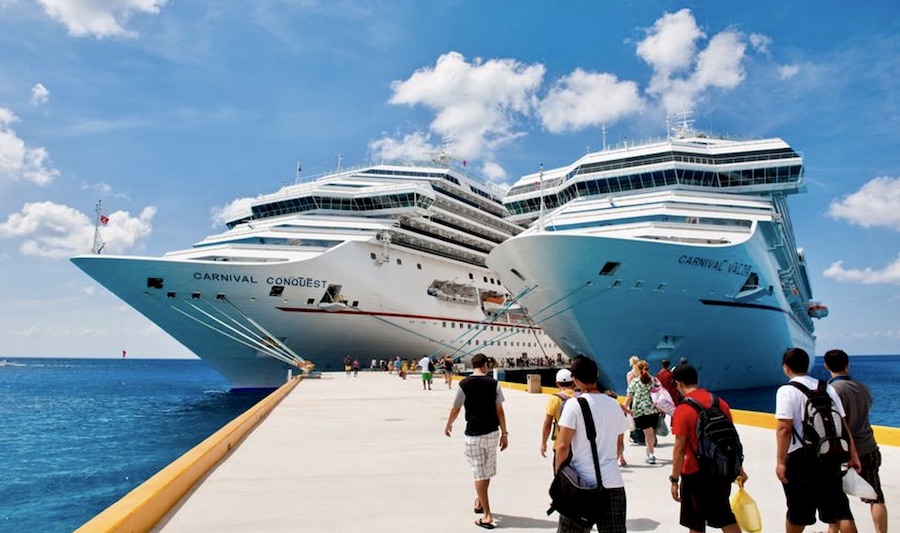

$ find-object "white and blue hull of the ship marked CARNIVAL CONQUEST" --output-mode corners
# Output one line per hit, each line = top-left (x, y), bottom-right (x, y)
(72, 241), (559, 389)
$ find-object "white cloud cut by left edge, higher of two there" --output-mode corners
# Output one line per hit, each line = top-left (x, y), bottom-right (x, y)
(0, 103), (59, 185)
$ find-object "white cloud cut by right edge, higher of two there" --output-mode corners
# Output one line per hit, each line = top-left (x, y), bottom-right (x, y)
(828, 176), (900, 231)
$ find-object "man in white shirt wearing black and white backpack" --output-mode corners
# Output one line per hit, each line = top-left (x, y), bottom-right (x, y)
(775, 348), (860, 533)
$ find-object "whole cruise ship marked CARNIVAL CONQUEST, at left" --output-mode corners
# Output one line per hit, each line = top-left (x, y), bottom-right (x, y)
(72, 160), (562, 390)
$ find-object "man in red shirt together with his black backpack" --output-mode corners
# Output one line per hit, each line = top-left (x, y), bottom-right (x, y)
(669, 364), (747, 533)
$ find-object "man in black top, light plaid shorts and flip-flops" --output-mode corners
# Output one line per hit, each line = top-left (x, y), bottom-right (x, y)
(444, 353), (509, 529)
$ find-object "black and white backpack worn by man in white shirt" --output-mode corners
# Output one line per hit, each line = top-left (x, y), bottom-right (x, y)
(789, 380), (850, 471)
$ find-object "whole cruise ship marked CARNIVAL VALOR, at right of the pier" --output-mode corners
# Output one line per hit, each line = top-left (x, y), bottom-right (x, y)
(487, 121), (828, 392)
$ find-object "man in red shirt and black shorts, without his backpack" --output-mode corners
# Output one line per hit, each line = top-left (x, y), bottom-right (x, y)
(669, 364), (747, 533)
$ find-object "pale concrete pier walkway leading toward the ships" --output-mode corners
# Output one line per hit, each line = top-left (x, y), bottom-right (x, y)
(125, 372), (900, 533)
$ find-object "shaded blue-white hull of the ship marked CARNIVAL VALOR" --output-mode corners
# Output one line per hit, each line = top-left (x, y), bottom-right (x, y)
(488, 232), (815, 393)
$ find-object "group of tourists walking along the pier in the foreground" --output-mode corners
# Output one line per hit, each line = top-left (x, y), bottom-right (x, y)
(444, 348), (887, 533)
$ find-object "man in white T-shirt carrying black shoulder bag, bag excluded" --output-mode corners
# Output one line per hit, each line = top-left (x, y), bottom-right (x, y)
(556, 355), (628, 533)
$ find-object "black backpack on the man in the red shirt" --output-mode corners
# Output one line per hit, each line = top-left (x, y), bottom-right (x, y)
(684, 392), (744, 482)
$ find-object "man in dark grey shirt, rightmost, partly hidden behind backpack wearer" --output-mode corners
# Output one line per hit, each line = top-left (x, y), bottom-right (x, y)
(825, 350), (888, 533)
